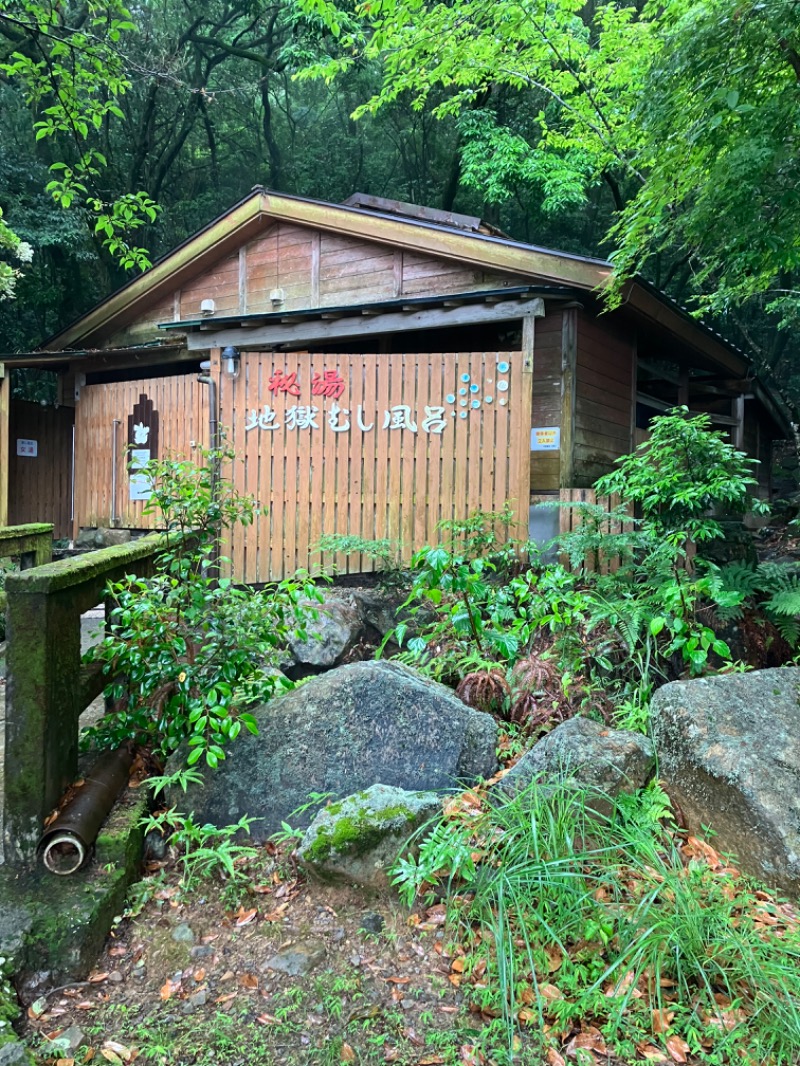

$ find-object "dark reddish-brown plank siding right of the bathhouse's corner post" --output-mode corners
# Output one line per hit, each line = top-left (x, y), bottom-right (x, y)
(573, 313), (635, 486)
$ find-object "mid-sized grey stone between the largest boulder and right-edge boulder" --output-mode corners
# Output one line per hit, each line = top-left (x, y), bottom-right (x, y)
(495, 717), (655, 809)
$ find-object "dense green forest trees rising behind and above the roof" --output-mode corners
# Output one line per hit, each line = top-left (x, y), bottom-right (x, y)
(0, 0), (800, 405)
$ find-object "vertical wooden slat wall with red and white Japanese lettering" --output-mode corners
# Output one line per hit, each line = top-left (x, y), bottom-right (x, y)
(220, 352), (530, 582)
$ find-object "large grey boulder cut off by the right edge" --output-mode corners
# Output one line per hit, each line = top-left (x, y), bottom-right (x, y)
(651, 668), (800, 898)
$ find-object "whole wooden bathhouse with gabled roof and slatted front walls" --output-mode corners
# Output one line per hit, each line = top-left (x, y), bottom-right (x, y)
(0, 188), (789, 582)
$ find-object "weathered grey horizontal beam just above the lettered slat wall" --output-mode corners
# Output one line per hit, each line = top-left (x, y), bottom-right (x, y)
(187, 296), (544, 352)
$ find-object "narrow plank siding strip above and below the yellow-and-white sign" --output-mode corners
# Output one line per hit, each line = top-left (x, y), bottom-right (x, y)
(530, 310), (563, 492)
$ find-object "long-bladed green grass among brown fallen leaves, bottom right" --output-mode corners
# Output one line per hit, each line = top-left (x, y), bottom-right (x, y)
(395, 784), (800, 1066)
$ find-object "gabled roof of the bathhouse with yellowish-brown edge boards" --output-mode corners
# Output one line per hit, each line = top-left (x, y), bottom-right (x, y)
(26, 185), (790, 432)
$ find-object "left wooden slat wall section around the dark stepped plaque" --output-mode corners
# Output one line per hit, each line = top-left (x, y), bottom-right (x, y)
(75, 374), (208, 532)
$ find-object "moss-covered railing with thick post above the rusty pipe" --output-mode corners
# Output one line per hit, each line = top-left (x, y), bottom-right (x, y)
(3, 534), (172, 863)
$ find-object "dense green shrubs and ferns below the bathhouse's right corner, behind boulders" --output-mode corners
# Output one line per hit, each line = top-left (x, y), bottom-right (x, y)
(369, 409), (800, 729)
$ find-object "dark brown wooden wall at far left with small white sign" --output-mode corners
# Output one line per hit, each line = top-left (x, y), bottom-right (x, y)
(9, 400), (74, 539)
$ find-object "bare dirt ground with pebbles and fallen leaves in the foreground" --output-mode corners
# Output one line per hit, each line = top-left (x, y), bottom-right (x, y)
(26, 849), (522, 1066)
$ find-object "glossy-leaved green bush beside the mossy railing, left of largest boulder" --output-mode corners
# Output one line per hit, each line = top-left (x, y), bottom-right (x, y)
(87, 450), (321, 766)
